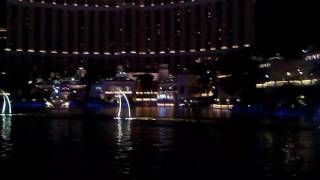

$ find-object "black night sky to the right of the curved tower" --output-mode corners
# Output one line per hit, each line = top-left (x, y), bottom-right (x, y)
(256, 0), (320, 54)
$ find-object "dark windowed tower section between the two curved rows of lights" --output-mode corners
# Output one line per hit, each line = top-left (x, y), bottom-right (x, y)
(8, 3), (244, 54)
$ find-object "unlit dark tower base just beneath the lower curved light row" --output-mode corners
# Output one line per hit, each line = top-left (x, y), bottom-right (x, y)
(1, 53), (228, 76)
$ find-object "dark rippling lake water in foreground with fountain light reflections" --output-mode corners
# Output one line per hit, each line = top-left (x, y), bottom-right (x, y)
(0, 115), (320, 180)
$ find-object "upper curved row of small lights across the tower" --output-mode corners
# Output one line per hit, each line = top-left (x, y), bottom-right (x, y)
(18, 0), (199, 8)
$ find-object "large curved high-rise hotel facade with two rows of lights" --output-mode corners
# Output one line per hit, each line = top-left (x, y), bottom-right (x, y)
(5, 0), (254, 77)
